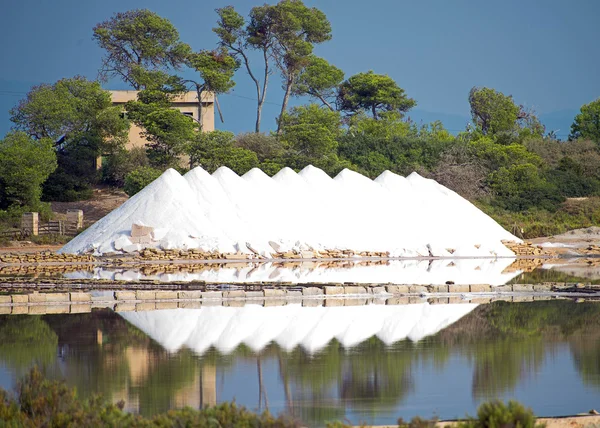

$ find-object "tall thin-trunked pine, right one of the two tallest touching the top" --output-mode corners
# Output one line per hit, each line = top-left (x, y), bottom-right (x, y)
(271, 0), (331, 133)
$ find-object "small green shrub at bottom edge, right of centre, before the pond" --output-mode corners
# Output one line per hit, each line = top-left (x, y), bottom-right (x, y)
(457, 400), (545, 428)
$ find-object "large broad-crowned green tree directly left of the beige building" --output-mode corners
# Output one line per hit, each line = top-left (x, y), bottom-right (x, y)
(11, 77), (129, 201)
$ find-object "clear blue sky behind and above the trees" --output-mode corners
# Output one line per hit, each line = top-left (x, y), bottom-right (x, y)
(0, 0), (600, 138)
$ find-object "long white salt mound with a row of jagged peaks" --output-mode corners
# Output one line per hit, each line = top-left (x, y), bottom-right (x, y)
(60, 166), (519, 258)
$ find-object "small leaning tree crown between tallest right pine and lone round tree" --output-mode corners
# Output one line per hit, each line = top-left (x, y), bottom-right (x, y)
(291, 55), (344, 111)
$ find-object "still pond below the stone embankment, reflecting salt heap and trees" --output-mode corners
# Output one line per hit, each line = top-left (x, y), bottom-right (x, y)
(0, 300), (600, 426)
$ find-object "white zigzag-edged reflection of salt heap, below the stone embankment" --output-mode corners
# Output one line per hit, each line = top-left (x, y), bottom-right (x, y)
(119, 303), (477, 354)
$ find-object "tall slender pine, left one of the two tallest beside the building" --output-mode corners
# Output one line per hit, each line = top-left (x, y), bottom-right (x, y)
(213, 5), (275, 132)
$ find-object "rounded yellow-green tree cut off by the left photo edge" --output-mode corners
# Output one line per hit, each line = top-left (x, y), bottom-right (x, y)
(0, 132), (56, 209)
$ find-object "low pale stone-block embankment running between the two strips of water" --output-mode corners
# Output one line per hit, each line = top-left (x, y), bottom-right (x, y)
(0, 283), (600, 315)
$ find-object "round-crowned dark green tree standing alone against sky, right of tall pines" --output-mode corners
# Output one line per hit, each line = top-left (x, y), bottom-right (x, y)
(337, 71), (417, 119)
